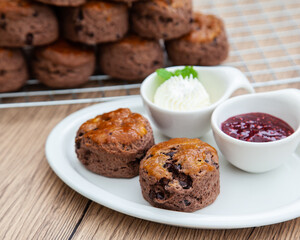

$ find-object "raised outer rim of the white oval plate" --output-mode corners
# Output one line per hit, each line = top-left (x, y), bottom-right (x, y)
(45, 96), (300, 229)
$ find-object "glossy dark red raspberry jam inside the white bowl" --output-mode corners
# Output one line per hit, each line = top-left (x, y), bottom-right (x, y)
(221, 113), (294, 142)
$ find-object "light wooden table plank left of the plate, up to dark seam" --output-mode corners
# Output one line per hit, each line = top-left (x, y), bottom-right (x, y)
(0, 106), (88, 239)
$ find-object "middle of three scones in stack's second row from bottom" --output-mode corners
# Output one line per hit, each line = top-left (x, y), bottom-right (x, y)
(61, 1), (128, 44)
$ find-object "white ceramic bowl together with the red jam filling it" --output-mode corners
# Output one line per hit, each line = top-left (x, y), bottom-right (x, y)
(211, 89), (300, 173)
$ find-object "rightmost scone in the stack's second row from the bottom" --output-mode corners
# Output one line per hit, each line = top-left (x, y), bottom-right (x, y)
(131, 0), (193, 40)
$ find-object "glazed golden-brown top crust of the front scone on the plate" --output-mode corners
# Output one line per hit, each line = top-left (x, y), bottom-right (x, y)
(140, 138), (218, 180)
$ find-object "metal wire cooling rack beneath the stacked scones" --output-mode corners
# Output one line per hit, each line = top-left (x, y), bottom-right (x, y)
(0, 0), (300, 108)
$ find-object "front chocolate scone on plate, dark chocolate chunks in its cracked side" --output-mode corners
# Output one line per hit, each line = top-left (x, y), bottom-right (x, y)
(140, 138), (220, 212)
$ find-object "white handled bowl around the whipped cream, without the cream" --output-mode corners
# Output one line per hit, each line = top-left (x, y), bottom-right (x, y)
(141, 66), (254, 138)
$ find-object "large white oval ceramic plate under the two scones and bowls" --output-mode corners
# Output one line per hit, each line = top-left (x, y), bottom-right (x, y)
(46, 97), (300, 229)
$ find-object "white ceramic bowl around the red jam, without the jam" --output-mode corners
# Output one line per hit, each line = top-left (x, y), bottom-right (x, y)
(211, 89), (300, 173)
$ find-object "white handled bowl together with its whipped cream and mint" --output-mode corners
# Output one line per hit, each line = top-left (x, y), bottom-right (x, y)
(141, 66), (254, 138)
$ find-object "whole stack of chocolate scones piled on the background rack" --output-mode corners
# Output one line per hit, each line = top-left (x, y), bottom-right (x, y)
(0, 0), (229, 92)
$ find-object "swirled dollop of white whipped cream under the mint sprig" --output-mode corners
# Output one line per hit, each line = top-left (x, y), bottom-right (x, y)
(154, 75), (211, 111)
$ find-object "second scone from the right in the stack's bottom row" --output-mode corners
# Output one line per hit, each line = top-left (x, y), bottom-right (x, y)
(99, 34), (163, 80)
